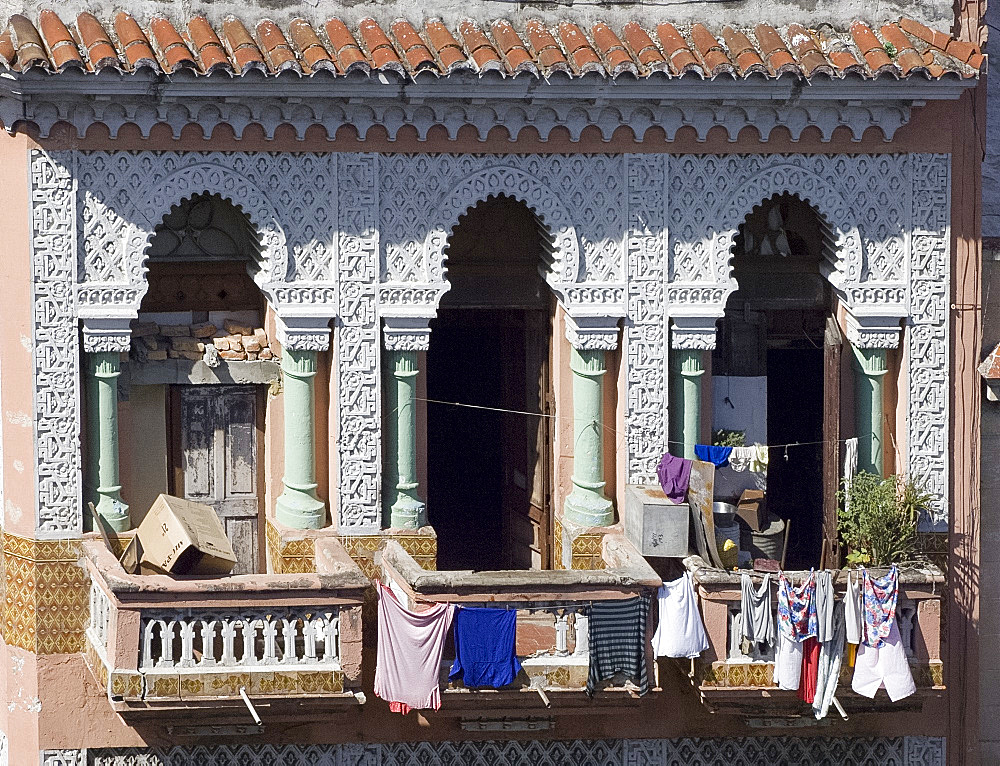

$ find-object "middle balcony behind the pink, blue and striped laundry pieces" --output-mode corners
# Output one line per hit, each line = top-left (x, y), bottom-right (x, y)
(377, 535), (661, 715)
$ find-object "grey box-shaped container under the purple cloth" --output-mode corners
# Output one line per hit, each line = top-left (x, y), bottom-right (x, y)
(623, 484), (691, 557)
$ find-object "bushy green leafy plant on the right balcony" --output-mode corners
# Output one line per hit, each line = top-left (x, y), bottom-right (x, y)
(837, 472), (933, 566)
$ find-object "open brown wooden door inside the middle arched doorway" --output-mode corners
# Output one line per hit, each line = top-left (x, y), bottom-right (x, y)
(502, 310), (553, 569)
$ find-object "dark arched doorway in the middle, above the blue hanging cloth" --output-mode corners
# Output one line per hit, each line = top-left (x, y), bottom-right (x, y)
(427, 196), (554, 570)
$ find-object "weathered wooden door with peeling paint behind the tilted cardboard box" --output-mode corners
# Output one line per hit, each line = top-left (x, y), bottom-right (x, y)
(170, 385), (263, 574)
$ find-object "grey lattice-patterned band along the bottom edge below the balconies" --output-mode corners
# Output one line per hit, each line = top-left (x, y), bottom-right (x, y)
(86, 737), (945, 766)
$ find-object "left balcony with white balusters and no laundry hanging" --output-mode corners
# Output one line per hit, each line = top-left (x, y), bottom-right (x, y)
(84, 540), (370, 722)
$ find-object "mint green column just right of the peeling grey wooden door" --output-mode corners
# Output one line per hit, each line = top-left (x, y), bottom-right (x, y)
(274, 348), (326, 529)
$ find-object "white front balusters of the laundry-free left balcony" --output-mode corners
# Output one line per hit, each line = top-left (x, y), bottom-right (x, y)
(139, 608), (339, 670)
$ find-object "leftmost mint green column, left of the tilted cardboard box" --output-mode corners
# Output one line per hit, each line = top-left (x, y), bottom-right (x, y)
(87, 351), (131, 532)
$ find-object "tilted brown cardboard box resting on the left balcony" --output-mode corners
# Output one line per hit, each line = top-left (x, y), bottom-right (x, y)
(136, 495), (236, 575)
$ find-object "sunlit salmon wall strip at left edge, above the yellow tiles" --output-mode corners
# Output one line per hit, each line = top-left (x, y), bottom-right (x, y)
(0, 132), (35, 537)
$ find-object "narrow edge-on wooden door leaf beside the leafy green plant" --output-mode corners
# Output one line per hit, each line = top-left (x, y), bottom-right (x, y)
(820, 317), (844, 569)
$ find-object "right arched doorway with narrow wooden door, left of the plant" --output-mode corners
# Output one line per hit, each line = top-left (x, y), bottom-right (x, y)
(712, 194), (842, 569)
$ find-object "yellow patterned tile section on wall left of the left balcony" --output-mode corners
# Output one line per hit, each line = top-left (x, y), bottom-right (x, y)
(0, 532), (90, 654)
